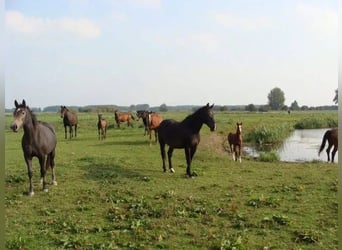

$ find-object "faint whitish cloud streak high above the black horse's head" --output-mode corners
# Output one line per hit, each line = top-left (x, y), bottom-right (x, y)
(213, 13), (271, 31)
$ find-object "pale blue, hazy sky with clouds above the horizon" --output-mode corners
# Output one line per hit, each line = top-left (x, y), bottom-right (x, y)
(5, 0), (338, 108)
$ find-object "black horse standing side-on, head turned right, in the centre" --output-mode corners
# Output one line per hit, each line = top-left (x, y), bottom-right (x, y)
(158, 103), (216, 177)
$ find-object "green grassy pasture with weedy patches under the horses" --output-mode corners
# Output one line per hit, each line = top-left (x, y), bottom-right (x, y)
(5, 112), (338, 250)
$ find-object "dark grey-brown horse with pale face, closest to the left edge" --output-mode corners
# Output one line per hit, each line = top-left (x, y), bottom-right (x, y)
(11, 100), (57, 196)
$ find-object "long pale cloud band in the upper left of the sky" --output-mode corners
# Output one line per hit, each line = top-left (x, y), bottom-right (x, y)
(5, 11), (101, 38)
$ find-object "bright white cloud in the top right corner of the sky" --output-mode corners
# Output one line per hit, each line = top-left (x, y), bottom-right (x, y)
(296, 3), (338, 38)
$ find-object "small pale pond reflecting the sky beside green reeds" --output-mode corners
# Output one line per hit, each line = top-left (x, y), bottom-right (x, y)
(244, 129), (338, 162)
